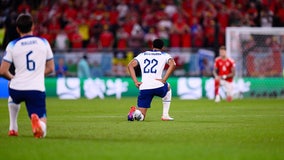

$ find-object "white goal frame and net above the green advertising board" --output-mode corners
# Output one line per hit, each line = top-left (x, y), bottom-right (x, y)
(226, 27), (284, 77)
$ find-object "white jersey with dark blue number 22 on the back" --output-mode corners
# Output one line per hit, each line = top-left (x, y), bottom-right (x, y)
(135, 51), (172, 90)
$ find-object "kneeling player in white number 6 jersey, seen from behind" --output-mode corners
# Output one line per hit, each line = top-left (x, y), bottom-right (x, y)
(0, 14), (54, 138)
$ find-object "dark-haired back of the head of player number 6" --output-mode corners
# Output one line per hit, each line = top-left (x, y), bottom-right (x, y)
(16, 13), (33, 33)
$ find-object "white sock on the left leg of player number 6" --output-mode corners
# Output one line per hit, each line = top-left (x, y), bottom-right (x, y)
(8, 97), (21, 131)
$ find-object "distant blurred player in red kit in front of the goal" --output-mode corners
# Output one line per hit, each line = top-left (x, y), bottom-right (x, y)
(213, 46), (235, 102)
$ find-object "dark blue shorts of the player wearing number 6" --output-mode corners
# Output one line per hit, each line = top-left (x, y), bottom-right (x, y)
(9, 88), (46, 118)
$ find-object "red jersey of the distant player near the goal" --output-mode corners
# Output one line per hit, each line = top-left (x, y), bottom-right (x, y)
(214, 57), (235, 82)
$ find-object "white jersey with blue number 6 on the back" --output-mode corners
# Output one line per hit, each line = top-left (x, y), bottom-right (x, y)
(3, 36), (53, 91)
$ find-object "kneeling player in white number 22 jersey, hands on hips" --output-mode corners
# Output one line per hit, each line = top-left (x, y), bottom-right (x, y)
(128, 39), (176, 121)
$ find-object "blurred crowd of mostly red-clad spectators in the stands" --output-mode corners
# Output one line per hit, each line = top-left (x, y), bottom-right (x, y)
(0, 0), (284, 52)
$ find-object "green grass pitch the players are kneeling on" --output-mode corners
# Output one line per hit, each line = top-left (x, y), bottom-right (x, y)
(0, 98), (284, 160)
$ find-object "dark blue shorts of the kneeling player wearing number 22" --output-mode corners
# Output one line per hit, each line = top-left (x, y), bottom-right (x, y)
(137, 83), (169, 108)
